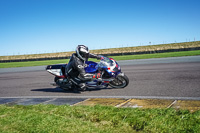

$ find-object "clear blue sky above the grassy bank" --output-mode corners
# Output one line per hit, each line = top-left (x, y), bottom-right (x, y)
(0, 0), (200, 56)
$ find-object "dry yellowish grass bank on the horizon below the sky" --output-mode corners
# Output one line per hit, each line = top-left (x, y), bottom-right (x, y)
(0, 41), (200, 60)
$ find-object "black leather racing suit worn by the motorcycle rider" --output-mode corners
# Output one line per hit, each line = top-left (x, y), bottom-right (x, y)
(65, 53), (100, 86)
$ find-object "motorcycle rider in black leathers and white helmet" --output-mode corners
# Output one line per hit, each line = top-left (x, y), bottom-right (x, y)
(65, 45), (101, 91)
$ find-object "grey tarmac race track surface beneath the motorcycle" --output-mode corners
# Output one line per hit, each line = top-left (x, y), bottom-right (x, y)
(0, 56), (200, 105)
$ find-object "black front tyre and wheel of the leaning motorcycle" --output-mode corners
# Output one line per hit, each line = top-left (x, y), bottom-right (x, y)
(109, 74), (129, 88)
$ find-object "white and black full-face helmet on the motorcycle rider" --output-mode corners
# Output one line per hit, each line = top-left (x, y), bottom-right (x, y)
(76, 45), (89, 61)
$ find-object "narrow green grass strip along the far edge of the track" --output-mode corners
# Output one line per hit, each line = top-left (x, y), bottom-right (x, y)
(0, 50), (200, 68)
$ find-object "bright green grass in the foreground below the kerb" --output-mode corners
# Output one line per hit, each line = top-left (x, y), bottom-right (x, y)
(0, 104), (200, 133)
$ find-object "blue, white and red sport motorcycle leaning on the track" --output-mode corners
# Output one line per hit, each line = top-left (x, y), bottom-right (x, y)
(46, 56), (129, 90)
